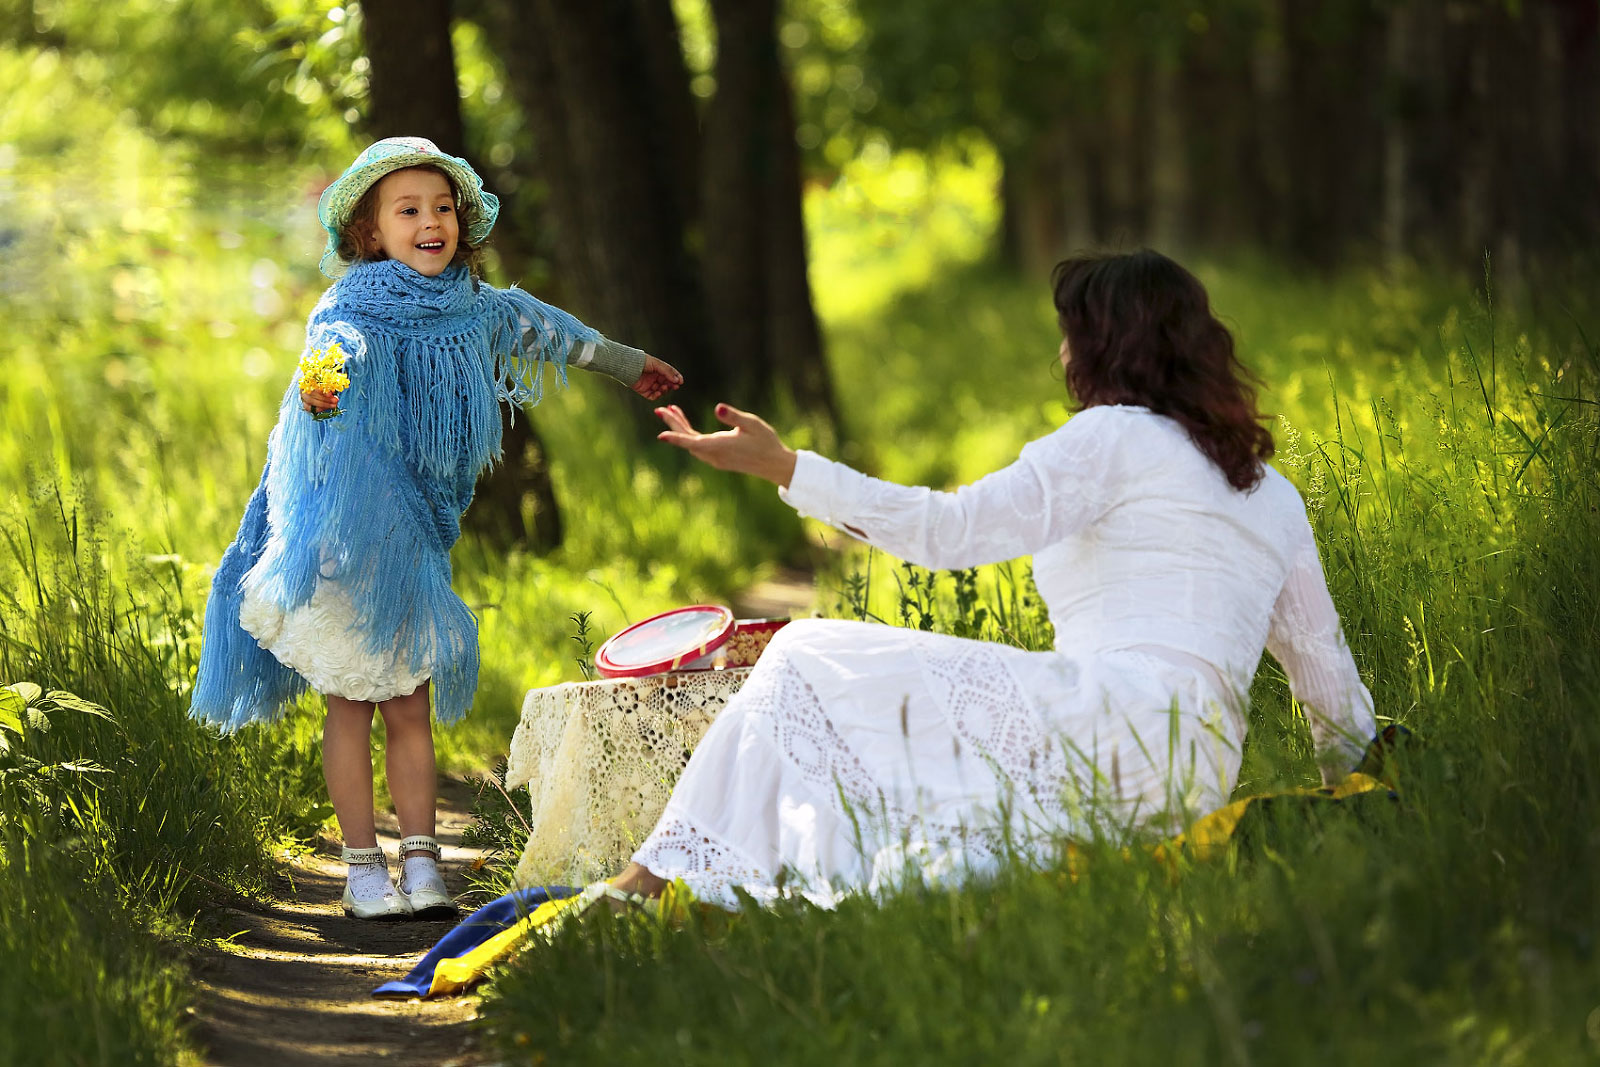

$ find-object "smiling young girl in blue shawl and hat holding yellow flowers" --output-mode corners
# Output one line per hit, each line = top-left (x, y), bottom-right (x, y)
(190, 138), (682, 918)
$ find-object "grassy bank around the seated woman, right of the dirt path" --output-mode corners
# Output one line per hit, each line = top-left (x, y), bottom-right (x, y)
(473, 267), (1600, 1064)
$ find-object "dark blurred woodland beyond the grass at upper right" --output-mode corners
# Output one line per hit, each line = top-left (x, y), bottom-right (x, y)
(808, 0), (1600, 277)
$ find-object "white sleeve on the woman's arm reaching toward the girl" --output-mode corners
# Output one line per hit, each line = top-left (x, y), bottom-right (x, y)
(781, 408), (1115, 569)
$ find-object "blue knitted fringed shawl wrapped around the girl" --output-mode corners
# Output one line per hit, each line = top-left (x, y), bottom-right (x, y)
(189, 259), (600, 729)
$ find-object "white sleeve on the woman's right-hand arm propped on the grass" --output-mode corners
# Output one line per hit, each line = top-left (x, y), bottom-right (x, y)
(1267, 518), (1376, 776)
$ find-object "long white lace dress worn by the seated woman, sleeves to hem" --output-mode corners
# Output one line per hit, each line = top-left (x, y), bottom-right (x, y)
(634, 406), (1374, 907)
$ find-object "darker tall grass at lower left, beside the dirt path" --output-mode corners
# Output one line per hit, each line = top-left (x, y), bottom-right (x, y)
(0, 498), (323, 1065)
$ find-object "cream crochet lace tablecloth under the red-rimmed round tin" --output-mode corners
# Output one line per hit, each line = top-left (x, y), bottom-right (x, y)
(506, 669), (750, 885)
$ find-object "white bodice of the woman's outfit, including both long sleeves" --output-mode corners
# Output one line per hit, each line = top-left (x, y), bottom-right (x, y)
(782, 406), (1374, 766)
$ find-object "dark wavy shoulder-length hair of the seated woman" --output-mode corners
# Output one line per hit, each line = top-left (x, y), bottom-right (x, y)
(1051, 250), (1272, 490)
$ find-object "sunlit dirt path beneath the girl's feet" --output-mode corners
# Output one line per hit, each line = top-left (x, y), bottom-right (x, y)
(186, 779), (490, 1067)
